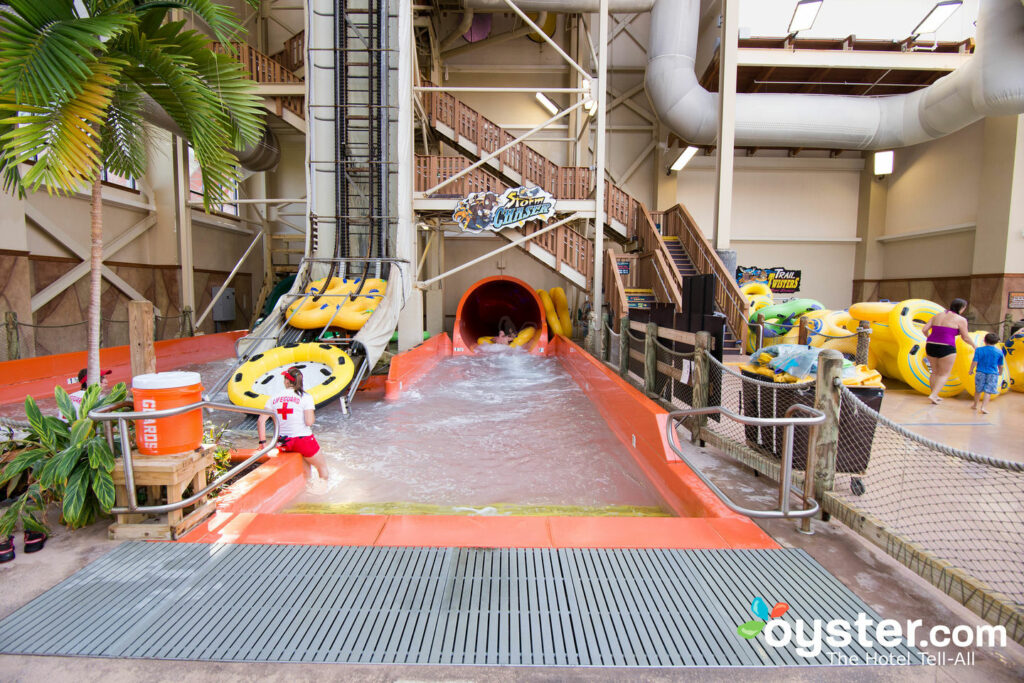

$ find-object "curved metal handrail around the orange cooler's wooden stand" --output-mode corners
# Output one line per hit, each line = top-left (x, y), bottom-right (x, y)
(89, 400), (281, 514)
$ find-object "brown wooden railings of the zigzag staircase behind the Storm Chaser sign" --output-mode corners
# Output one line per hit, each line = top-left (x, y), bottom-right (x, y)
(416, 83), (746, 341)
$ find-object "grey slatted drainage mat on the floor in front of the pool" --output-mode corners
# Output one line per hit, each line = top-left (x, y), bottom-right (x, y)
(0, 543), (920, 667)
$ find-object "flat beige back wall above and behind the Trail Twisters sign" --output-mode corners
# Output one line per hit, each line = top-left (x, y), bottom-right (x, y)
(660, 157), (862, 308)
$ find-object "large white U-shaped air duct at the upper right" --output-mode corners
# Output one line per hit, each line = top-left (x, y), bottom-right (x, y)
(647, 0), (1024, 150)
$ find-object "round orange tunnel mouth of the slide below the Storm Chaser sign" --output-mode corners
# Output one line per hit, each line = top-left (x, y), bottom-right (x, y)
(452, 275), (548, 355)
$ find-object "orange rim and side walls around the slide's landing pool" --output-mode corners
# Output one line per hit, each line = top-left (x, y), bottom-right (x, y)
(180, 334), (779, 549)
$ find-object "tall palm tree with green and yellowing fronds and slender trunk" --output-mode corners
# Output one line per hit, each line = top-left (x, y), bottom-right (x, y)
(0, 0), (263, 384)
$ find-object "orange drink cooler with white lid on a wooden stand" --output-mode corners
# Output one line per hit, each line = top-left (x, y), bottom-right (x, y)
(131, 372), (203, 456)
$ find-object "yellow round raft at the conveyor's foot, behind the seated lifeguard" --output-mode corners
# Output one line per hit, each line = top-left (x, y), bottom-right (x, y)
(227, 343), (355, 408)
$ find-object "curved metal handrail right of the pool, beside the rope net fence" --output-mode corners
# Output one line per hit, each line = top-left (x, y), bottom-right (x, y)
(665, 403), (825, 519)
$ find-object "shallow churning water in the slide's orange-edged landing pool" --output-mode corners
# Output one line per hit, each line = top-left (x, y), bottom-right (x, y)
(284, 347), (666, 508)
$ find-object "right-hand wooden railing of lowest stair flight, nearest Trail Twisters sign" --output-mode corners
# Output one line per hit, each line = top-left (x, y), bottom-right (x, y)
(657, 204), (750, 348)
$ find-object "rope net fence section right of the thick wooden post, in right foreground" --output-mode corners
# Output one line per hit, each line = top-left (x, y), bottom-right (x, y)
(833, 387), (1024, 609)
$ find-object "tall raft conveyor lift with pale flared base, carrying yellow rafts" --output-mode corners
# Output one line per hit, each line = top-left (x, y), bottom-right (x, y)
(210, 0), (413, 405)
